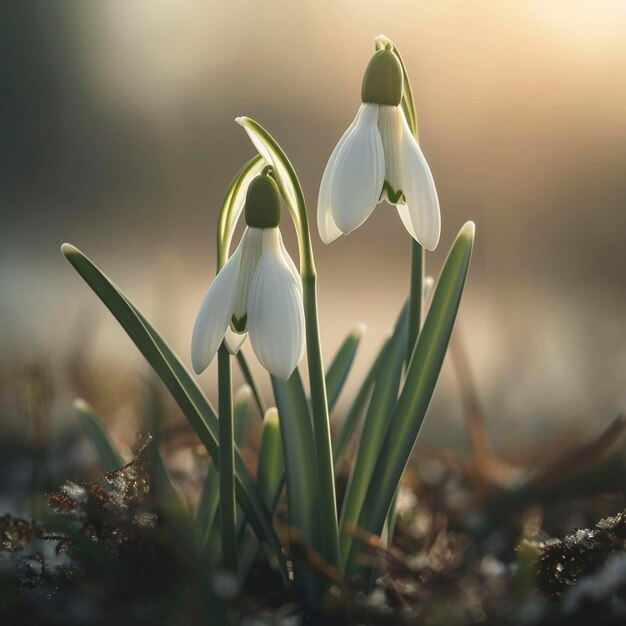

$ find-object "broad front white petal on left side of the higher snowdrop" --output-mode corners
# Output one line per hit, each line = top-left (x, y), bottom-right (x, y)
(330, 104), (385, 235)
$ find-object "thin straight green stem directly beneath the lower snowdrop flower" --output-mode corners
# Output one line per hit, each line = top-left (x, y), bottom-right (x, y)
(217, 344), (237, 574)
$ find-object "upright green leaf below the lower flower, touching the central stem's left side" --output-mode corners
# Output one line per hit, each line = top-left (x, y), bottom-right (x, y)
(272, 368), (321, 592)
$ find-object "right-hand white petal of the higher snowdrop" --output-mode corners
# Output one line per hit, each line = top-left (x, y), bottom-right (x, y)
(401, 108), (441, 250)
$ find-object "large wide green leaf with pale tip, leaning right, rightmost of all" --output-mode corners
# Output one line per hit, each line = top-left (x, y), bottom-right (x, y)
(347, 222), (475, 573)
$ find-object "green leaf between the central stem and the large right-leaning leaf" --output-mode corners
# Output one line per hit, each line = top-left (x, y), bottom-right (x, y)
(340, 304), (408, 563)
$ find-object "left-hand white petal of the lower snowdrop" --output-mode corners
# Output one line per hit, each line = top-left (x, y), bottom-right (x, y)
(191, 242), (243, 374)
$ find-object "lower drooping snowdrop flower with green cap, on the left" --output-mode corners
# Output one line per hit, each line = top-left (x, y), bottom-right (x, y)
(191, 175), (304, 380)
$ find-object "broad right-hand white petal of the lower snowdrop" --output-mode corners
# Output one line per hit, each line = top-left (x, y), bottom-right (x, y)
(248, 228), (304, 380)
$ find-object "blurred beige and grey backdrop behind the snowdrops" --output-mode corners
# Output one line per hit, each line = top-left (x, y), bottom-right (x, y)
(0, 0), (626, 468)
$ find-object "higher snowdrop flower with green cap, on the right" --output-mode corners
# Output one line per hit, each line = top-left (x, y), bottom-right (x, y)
(317, 44), (441, 250)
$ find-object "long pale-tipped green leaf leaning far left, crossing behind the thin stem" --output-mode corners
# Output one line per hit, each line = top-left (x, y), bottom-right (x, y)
(62, 244), (289, 584)
